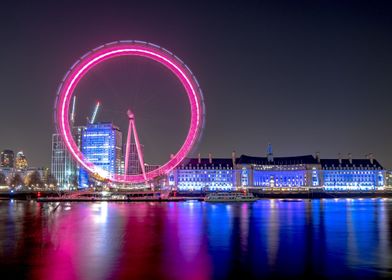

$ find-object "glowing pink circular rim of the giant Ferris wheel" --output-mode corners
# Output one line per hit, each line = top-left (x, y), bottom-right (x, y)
(54, 41), (205, 184)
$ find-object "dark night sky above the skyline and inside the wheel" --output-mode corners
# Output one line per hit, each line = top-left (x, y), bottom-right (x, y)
(0, 0), (392, 168)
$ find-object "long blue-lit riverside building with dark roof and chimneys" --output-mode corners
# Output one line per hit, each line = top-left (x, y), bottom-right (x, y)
(174, 152), (386, 191)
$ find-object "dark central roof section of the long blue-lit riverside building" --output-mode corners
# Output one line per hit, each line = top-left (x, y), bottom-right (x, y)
(236, 155), (318, 165)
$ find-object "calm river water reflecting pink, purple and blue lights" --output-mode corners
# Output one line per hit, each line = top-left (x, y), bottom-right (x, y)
(0, 198), (392, 280)
